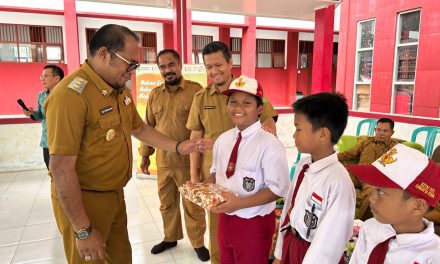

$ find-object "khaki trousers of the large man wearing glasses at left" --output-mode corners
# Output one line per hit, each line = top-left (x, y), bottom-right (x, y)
(51, 182), (132, 264)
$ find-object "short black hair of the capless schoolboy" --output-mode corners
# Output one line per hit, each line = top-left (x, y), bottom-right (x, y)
(292, 93), (348, 144)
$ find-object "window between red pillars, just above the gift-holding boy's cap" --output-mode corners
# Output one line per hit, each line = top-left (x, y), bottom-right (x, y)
(257, 39), (285, 68)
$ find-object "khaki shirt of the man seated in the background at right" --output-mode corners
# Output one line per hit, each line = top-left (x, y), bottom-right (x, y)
(338, 136), (401, 164)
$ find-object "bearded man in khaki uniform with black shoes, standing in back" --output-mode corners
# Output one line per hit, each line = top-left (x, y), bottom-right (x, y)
(140, 49), (209, 261)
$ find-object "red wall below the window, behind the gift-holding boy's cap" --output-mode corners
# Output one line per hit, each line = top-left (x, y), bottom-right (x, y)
(232, 67), (292, 106)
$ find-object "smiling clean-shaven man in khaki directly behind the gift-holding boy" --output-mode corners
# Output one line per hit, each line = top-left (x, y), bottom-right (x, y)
(186, 41), (277, 263)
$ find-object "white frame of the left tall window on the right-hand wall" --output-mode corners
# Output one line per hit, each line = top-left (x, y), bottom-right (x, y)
(352, 18), (376, 112)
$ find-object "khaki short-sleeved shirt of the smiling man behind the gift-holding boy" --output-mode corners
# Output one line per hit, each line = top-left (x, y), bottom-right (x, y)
(186, 84), (278, 173)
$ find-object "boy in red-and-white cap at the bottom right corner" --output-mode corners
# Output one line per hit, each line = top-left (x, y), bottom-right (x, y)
(348, 144), (440, 264)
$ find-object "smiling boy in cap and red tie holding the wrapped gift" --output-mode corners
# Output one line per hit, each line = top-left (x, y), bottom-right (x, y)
(207, 76), (289, 264)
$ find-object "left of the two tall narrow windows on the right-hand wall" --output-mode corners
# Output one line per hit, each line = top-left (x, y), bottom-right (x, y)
(353, 20), (375, 111)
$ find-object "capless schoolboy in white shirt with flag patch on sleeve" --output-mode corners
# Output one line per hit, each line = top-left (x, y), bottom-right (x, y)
(273, 93), (355, 264)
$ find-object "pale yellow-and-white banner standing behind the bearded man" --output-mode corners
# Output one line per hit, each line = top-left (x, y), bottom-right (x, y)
(136, 64), (207, 174)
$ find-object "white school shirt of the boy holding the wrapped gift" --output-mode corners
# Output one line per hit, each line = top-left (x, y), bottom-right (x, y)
(210, 121), (289, 219)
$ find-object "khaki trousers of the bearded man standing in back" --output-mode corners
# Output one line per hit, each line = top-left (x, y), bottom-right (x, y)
(157, 167), (206, 248)
